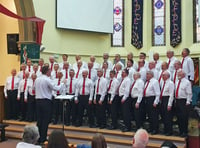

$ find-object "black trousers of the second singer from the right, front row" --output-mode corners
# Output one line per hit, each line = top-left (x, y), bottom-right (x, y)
(160, 96), (173, 133)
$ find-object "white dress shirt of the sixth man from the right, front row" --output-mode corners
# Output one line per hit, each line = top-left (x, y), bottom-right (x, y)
(107, 78), (119, 101)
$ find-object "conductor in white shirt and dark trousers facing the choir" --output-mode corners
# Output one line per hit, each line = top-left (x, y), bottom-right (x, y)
(35, 66), (62, 143)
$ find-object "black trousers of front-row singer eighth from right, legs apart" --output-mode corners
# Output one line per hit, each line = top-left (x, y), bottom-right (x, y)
(78, 95), (94, 125)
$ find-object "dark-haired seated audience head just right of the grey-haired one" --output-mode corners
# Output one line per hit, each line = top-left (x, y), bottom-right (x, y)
(48, 130), (69, 148)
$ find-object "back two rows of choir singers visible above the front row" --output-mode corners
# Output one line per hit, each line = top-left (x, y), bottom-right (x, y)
(18, 48), (194, 82)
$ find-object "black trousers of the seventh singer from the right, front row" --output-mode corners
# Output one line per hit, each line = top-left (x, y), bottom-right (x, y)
(96, 95), (106, 127)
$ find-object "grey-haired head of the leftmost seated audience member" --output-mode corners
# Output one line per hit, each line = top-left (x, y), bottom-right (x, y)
(22, 125), (40, 144)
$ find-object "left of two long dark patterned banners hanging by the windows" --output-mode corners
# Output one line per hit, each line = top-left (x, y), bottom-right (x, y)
(131, 0), (143, 49)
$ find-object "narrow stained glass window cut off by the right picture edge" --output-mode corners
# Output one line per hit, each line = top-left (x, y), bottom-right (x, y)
(193, 0), (200, 42)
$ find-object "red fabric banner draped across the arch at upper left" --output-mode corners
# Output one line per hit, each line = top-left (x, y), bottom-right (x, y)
(0, 4), (45, 45)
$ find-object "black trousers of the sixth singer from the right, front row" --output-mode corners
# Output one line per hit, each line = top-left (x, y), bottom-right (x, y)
(111, 95), (121, 128)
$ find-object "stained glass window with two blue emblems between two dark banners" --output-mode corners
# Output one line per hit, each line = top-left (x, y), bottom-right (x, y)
(152, 0), (165, 46)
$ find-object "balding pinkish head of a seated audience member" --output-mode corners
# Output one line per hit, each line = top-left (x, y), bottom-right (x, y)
(133, 129), (149, 148)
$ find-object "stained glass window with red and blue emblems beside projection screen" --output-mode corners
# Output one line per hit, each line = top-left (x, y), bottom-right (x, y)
(111, 0), (124, 47)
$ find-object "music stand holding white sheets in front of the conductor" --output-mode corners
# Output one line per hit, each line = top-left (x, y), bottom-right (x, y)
(55, 95), (75, 131)
